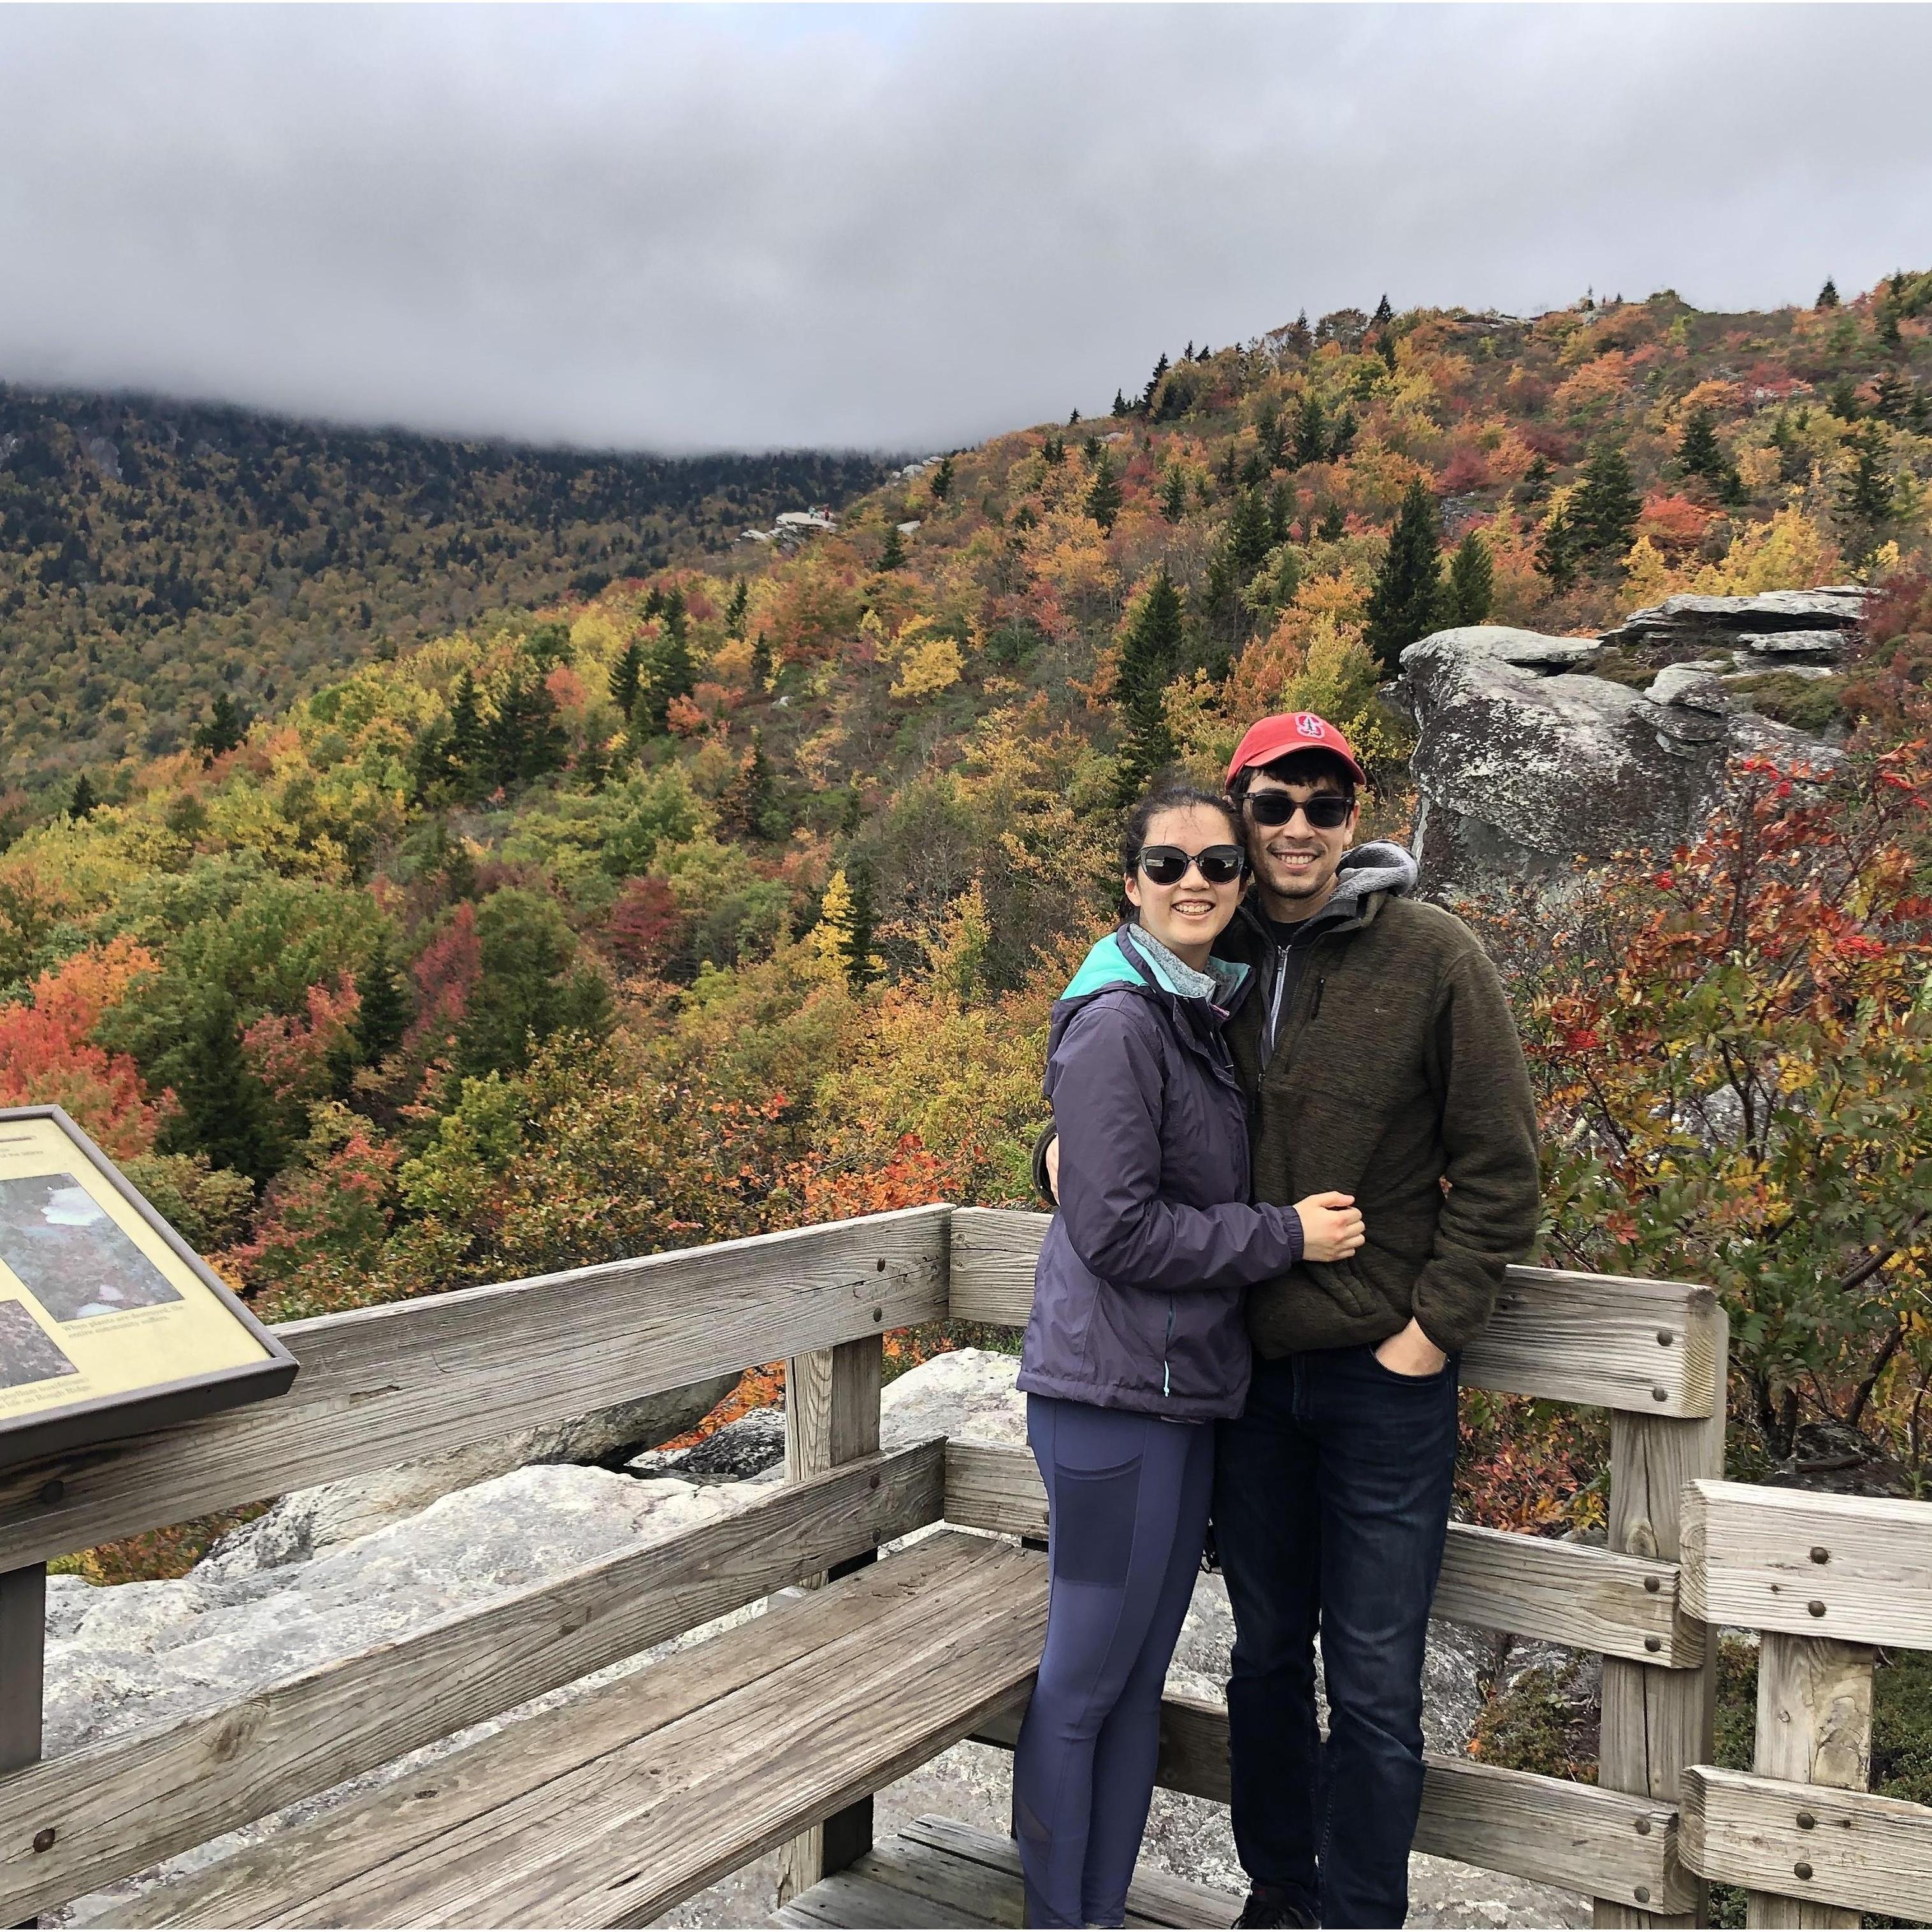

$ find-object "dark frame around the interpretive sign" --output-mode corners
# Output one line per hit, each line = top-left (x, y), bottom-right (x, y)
(0, 1105), (301, 1470)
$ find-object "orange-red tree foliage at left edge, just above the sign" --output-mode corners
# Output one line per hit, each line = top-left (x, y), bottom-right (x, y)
(0, 937), (172, 1161)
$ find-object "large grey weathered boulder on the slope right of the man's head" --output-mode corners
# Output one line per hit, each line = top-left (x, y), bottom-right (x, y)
(1399, 622), (1839, 893)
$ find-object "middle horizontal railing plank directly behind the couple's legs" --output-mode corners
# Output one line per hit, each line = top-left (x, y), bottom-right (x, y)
(947, 1439), (1704, 1669)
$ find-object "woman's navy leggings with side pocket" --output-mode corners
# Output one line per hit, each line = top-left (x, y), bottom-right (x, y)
(1013, 1395), (1213, 1926)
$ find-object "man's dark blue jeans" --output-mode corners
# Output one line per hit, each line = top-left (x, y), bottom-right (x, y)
(1213, 1348), (1457, 1926)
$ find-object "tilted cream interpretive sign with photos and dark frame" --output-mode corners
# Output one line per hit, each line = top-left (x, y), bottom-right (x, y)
(0, 1107), (296, 1464)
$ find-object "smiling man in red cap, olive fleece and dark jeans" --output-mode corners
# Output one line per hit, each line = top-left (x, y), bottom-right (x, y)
(1053, 711), (1540, 1926)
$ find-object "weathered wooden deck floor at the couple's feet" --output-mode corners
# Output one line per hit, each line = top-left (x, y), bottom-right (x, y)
(779, 1818), (1241, 1932)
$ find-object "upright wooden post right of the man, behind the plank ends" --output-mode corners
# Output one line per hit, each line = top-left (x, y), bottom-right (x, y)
(1590, 1310), (1729, 1926)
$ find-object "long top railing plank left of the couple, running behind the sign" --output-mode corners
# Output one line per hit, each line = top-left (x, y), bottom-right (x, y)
(0, 1208), (953, 1569)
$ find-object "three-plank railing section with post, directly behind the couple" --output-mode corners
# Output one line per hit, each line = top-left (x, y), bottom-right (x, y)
(947, 1208), (1727, 1926)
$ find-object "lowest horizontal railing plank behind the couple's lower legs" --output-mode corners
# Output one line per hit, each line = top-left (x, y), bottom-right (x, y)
(974, 1696), (1694, 1911)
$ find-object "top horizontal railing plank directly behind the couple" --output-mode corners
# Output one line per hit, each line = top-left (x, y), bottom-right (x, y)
(951, 1208), (1724, 1416)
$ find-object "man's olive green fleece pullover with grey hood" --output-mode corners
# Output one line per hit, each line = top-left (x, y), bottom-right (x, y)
(1215, 846), (1542, 1356)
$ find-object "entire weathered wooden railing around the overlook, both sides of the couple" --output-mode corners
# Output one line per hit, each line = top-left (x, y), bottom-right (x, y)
(0, 1206), (1932, 1924)
